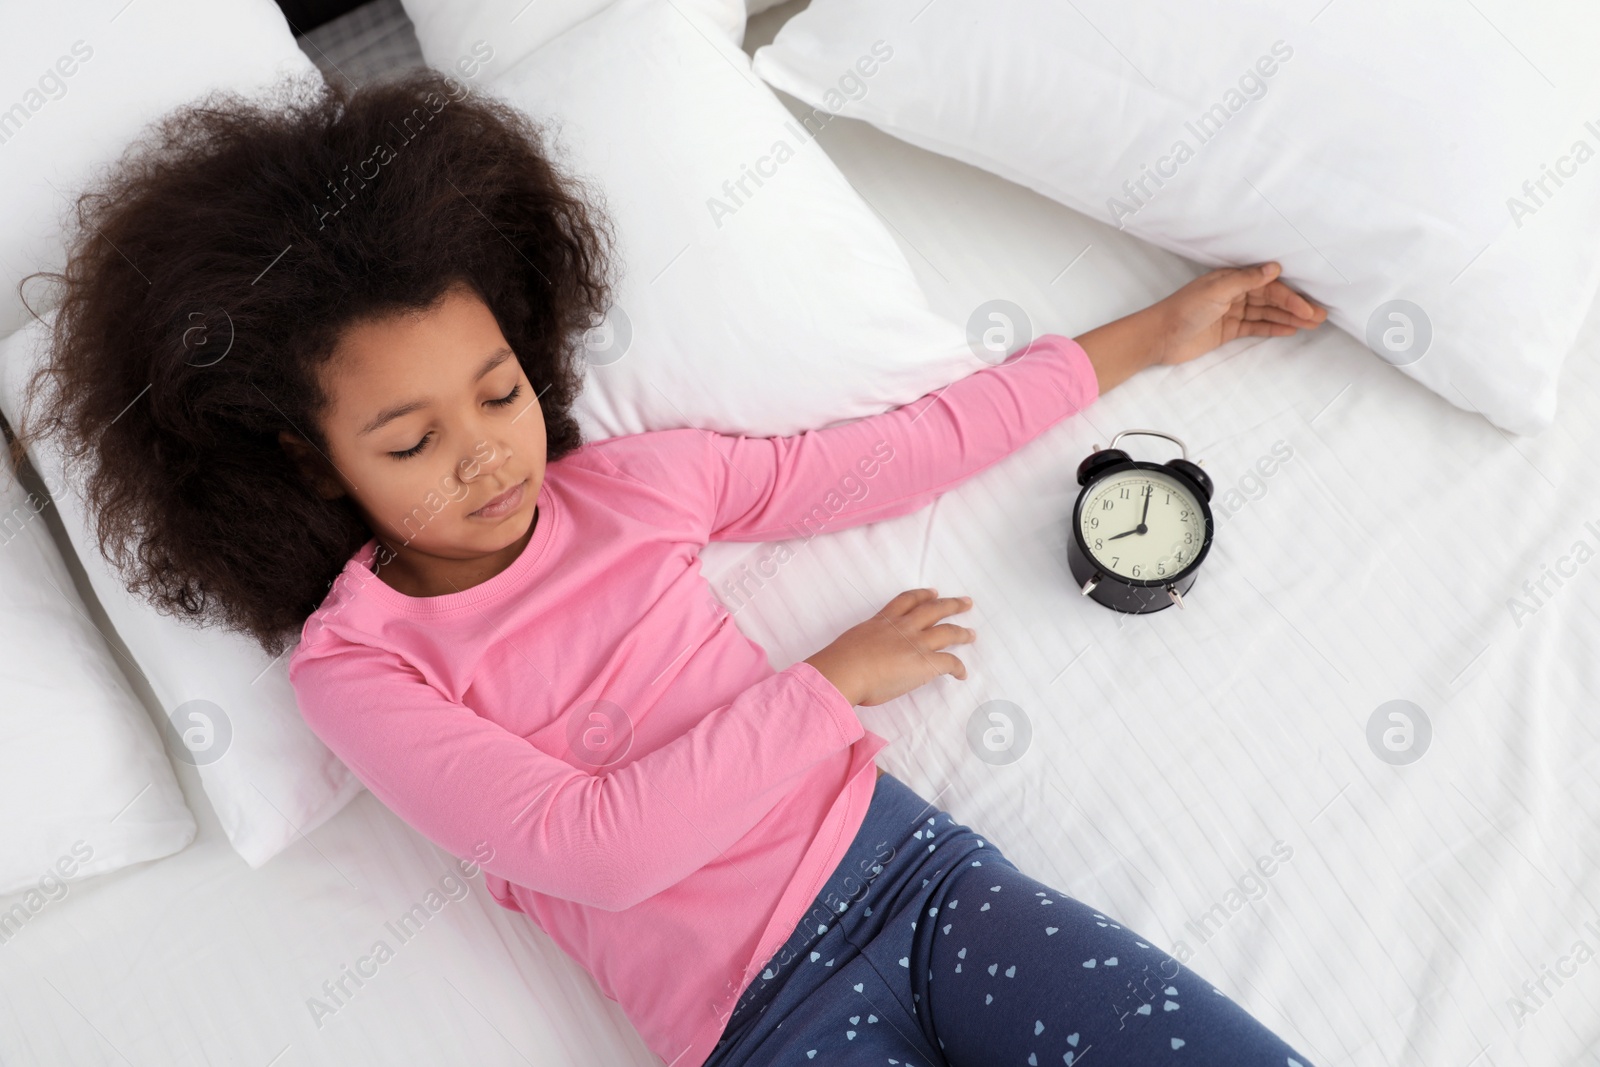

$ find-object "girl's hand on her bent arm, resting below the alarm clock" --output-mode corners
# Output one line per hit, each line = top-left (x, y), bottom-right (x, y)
(806, 589), (978, 707)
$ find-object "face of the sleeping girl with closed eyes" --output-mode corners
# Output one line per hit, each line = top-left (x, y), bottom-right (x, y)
(280, 286), (546, 597)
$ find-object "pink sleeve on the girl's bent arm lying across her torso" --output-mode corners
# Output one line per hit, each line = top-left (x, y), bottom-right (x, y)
(291, 638), (866, 912)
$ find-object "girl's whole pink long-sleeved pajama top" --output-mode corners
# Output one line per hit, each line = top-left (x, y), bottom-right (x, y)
(290, 334), (1098, 1067)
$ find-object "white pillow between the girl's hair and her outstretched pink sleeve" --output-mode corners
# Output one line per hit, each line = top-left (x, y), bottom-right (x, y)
(473, 0), (986, 437)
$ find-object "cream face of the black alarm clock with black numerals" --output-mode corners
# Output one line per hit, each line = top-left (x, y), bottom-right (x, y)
(1078, 469), (1205, 582)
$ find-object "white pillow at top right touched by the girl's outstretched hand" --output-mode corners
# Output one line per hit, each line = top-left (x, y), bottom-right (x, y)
(755, 0), (1600, 432)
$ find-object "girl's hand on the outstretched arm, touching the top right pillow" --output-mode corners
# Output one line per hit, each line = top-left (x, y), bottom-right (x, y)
(1150, 262), (1328, 363)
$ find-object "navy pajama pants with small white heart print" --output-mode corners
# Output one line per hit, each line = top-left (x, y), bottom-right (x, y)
(706, 774), (1314, 1067)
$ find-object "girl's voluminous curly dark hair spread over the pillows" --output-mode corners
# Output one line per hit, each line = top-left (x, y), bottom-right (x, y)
(14, 70), (613, 656)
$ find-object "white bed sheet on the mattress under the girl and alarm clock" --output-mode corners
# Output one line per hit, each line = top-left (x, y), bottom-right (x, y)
(0, 10), (1600, 1067)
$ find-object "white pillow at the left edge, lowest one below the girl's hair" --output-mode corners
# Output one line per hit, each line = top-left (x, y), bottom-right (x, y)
(0, 438), (195, 895)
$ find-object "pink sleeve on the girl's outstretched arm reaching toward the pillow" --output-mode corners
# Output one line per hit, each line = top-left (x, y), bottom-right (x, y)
(654, 334), (1099, 541)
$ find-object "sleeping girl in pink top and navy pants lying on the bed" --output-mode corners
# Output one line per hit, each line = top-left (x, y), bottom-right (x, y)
(21, 72), (1325, 1067)
